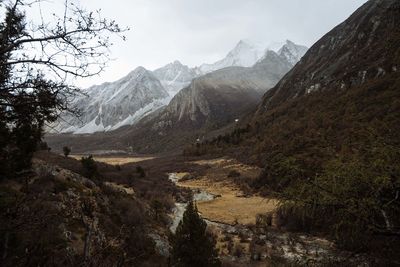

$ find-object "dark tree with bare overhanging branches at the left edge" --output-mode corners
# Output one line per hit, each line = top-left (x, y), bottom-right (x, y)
(0, 0), (125, 177)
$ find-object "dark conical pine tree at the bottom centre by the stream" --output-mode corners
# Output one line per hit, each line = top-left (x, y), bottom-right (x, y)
(171, 202), (221, 267)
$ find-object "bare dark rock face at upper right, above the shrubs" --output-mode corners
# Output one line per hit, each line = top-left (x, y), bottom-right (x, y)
(259, 0), (400, 112)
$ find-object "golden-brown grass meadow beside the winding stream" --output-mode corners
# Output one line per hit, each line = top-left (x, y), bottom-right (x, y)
(178, 159), (277, 227)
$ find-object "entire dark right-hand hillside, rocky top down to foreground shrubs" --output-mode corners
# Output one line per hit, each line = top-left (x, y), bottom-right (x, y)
(191, 0), (400, 266)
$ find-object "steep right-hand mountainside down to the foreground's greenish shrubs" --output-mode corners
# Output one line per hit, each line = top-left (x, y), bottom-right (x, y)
(206, 0), (400, 175)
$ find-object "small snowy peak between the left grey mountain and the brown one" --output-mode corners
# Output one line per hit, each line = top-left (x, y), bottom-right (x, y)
(153, 61), (197, 97)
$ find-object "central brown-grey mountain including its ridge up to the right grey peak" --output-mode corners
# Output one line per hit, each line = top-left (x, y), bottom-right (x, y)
(158, 51), (291, 130)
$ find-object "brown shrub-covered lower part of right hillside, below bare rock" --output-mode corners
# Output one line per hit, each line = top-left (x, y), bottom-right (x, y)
(190, 74), (400, 257)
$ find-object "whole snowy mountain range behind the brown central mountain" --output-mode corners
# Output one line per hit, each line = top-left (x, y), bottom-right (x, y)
(50, 41), (307, 134)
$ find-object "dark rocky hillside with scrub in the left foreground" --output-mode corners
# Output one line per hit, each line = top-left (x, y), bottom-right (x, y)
(0, 151), (182, 267)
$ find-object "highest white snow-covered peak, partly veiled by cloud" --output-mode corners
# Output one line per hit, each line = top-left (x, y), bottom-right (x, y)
(198, 40), (265, 74)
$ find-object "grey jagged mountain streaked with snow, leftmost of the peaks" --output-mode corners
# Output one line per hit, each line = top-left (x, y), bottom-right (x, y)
(54, 67), (169, 134)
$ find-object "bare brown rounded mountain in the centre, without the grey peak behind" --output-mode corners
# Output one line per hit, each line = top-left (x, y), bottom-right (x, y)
(159, 67), (267, 129)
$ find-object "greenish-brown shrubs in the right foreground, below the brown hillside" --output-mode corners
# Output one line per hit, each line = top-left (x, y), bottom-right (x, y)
(279, 138), (400, 249)
